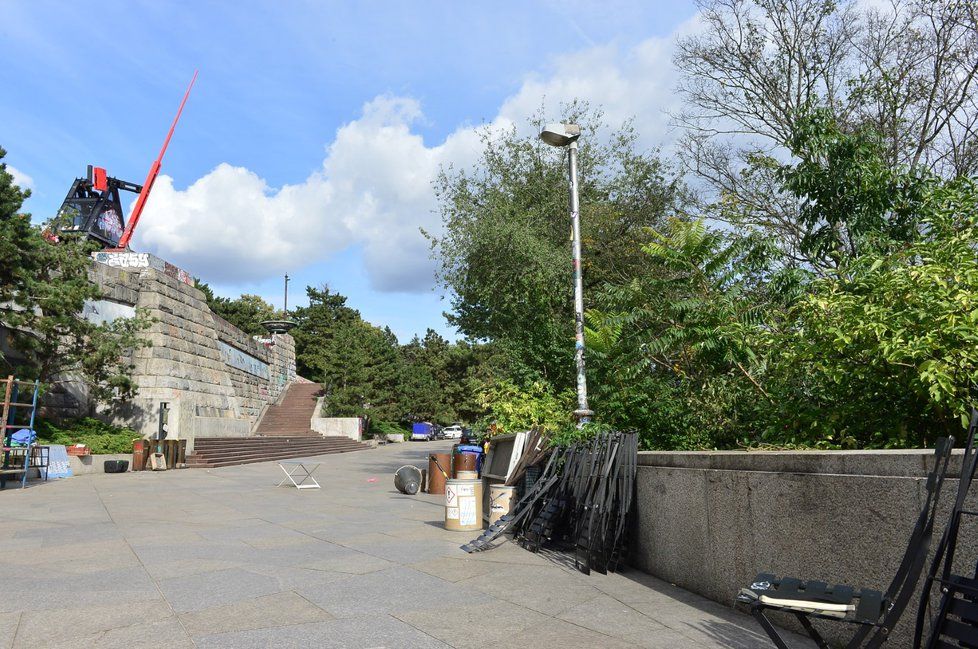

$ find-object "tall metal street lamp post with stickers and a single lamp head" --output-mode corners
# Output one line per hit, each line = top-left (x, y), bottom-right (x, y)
(540, 124), (594, 427)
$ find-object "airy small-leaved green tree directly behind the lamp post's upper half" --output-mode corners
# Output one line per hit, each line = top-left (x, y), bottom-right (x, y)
(432, 104), (681, 389)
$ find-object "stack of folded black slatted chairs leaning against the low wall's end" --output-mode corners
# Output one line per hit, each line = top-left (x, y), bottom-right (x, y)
(462, 432), (638, 574)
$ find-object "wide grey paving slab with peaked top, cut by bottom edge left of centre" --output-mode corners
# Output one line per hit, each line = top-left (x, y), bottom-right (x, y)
(195, 615), (450, 649)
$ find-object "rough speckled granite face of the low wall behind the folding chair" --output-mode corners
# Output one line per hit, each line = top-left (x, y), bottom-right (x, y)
(629, 450), (978, 647)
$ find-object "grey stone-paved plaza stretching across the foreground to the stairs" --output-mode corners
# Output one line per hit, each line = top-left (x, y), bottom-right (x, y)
(0, 442), (801, 649)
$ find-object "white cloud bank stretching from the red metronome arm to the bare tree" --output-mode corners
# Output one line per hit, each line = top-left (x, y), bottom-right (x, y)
(137, 23), (688, 291)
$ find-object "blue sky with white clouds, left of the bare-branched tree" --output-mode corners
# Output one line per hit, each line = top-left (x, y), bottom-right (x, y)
(0, 0), (695, 341)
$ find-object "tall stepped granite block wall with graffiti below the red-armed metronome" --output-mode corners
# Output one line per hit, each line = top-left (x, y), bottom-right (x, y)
(44, 253), (295, 452)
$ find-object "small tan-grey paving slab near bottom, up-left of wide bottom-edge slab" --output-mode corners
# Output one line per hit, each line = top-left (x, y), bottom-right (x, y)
(180, 591), (333, 636)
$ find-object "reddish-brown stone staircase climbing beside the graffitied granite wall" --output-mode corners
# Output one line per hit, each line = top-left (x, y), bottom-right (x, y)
(187, 383), (370, 468)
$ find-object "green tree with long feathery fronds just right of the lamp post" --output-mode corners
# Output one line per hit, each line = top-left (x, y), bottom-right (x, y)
(587, 219), (784, 449)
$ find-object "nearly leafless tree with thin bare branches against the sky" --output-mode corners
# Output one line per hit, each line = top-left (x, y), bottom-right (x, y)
(675, 0), (978, 272)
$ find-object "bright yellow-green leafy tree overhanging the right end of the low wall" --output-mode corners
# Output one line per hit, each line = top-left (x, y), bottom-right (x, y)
(758, 179), (978, 447)
